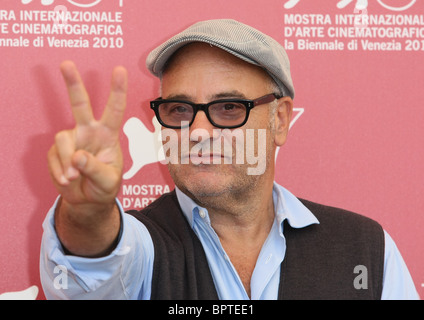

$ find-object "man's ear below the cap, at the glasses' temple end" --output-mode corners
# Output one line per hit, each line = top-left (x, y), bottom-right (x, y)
(274, 97), (293, 147)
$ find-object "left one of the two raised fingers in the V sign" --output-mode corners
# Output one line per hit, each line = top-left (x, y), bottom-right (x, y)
(60, 61), (94, 124)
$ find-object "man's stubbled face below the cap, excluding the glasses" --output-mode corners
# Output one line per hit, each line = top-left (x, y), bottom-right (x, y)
(162, 43), (290, 204)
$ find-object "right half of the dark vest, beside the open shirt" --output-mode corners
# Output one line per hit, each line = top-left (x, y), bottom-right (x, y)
(283, 199), (384, 299)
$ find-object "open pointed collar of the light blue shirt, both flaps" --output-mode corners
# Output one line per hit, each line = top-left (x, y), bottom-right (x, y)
(175, 182), (319, 230)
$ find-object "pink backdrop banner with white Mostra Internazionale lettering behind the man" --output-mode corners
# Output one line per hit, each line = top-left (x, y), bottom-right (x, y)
(0, 0), (424, 299)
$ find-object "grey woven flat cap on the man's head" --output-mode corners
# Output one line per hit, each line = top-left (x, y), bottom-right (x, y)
(146, 20), (294, 98)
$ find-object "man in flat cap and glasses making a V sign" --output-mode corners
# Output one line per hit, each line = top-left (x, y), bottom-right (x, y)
(41, 20), (417, 299)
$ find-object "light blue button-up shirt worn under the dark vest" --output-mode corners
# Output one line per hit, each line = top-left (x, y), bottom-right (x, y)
(40, 183), (419, 300)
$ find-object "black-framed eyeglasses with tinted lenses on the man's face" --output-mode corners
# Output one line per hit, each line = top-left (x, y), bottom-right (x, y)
(150, 93), (281, 129)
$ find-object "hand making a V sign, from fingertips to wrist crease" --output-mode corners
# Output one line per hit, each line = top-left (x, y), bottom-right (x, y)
(48, 61), (127, 204)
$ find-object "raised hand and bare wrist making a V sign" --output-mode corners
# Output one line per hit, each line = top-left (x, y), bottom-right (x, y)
(48, 61), (127, 255)
